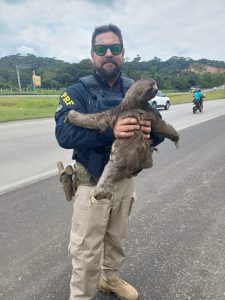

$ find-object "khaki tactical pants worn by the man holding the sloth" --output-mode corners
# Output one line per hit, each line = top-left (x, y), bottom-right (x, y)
(69, 178), (134, 300)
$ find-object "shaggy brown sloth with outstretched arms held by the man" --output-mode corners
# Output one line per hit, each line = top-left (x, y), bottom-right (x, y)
(65, 78), (179, 202)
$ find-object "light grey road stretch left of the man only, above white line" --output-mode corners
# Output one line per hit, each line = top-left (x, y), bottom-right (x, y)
(0, 119), (72, 193)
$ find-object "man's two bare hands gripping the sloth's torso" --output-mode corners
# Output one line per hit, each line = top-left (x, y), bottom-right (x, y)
(113, 118), (151, 139)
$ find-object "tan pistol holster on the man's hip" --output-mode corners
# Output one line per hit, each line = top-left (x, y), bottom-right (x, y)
(57, 161), (79, 201)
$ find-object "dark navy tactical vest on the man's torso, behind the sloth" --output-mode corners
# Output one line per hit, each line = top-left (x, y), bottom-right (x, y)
(74, 75), (134, 177)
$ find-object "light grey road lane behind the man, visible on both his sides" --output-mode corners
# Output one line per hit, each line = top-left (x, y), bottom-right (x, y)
(0, 99), (225, 193)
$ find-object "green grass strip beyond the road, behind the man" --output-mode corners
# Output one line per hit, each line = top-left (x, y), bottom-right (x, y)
(0, 89), (225, 122)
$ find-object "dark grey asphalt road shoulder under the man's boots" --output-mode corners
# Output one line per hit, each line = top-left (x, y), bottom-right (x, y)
(0, 102), (225, 300)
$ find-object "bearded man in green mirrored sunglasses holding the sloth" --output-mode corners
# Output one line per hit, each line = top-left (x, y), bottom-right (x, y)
(55, 24), (162, 300)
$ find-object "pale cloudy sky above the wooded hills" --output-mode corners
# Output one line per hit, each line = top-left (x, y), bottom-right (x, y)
(0, 0), (225, 63)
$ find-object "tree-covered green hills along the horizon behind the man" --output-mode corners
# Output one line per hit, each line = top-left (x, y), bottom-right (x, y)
(0, 54), (225, 91)
